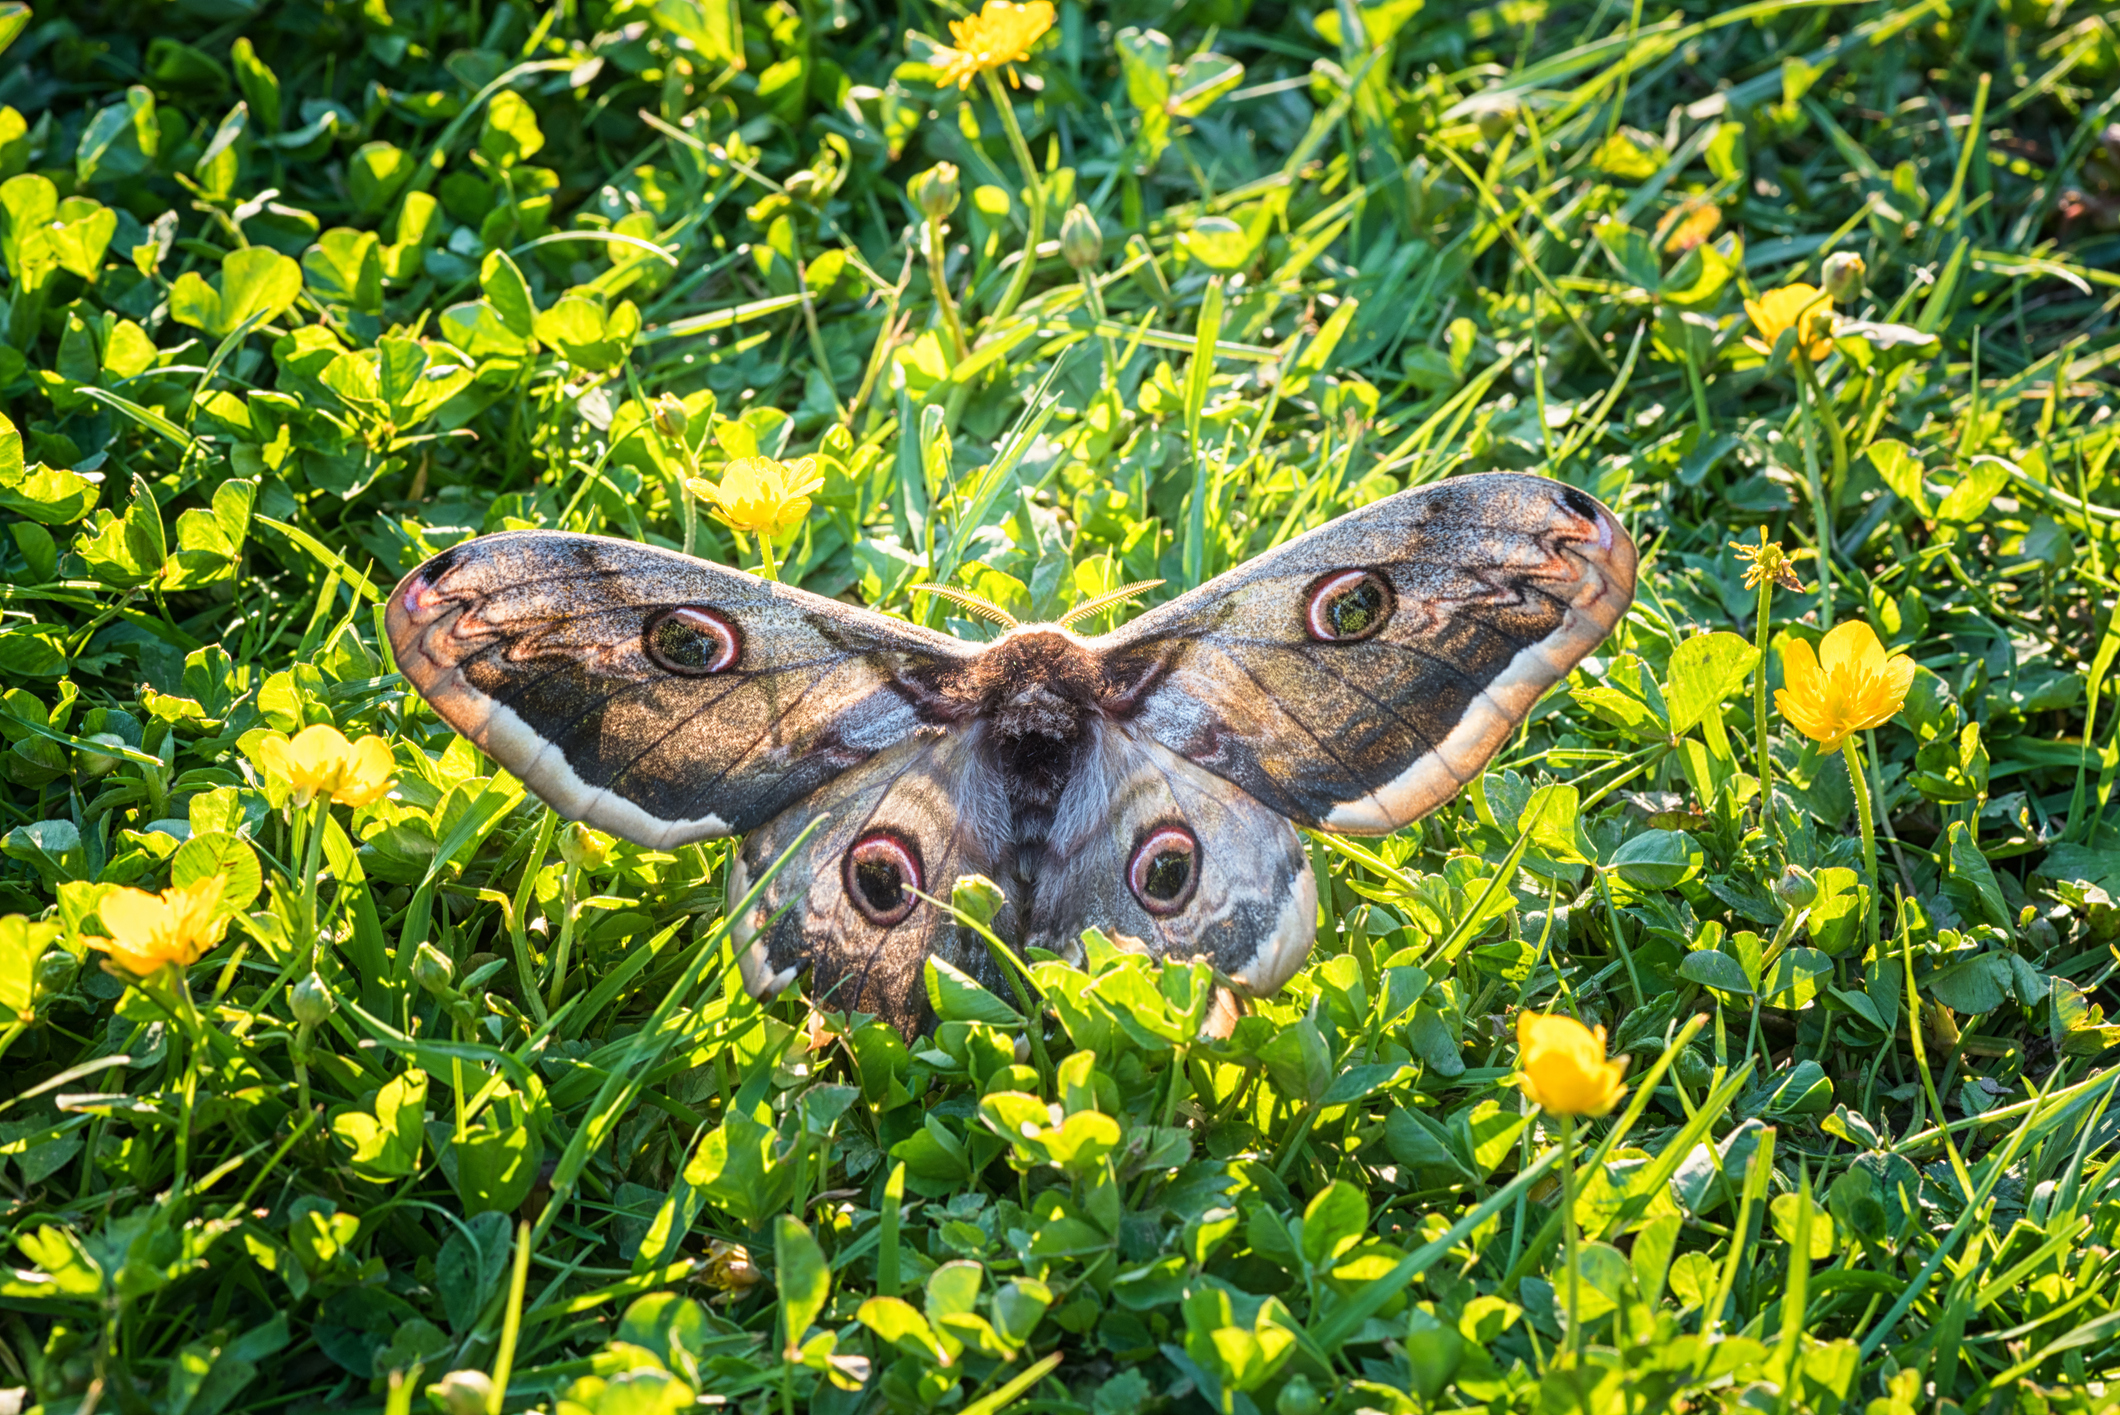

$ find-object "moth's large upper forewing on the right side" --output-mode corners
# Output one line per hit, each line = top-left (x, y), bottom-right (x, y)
(1096, 473), (1637, 834)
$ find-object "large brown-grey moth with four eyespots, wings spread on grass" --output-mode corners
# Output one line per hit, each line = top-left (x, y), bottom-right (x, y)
(386, 473), (1637, 1035)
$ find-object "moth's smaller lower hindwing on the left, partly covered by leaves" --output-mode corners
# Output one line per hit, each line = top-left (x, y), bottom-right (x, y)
(729, 732), (1018, 1035)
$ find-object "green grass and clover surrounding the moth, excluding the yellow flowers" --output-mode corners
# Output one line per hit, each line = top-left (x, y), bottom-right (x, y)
(0, 0), (2120, 1415)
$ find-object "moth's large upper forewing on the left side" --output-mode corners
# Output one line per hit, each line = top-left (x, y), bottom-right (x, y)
(386, 530), (971, 849)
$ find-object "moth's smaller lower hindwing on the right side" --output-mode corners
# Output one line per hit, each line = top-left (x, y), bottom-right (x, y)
(1026, 728), (1319, 995)
